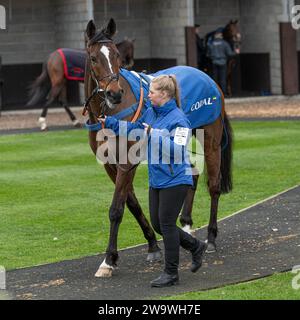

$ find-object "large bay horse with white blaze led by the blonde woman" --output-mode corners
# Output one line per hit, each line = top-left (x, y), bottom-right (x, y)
(84, 19), (232, 277)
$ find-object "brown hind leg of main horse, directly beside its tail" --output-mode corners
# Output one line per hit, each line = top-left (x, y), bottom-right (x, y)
(204, 118), (223, 252)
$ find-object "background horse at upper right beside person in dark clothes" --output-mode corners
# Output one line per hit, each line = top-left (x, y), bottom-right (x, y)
(201, 20), (241, 97)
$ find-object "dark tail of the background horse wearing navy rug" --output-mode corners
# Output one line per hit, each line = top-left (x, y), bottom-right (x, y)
(26, 62), (51, 107)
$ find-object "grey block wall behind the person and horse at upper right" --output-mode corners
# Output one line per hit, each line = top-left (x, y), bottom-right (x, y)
(195, 0), (288, 94)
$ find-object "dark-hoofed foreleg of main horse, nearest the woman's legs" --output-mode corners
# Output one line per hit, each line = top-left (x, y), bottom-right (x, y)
(126, 187), (161, 261)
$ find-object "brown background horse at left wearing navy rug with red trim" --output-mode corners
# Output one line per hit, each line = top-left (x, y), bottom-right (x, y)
(26, 38), (134, 131)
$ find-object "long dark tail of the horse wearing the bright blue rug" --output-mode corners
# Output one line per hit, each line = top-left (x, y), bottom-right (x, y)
(221, 112), (233, 193)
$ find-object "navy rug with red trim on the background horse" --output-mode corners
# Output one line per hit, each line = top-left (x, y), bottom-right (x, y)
(57, 48), (87, 81)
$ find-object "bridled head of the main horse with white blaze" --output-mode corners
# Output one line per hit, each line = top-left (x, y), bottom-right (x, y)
(86, 19), (123, 109)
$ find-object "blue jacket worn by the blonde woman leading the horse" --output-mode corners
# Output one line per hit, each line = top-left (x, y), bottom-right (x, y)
(105, 99), (193, 188)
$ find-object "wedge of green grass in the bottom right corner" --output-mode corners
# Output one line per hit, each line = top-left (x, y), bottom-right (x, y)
(159, 272), (300, 300)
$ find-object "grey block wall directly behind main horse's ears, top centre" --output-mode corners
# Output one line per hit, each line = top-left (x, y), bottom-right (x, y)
(94, 0), (194, 64)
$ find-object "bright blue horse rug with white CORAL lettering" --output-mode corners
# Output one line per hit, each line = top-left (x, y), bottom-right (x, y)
(120, 66), (222, 129)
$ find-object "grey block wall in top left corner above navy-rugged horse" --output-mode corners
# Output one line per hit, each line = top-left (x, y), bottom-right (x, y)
(0, 0), (56, 65)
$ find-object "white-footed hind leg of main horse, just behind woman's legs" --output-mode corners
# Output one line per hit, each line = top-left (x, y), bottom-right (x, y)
(179, 165), (199, 233)
